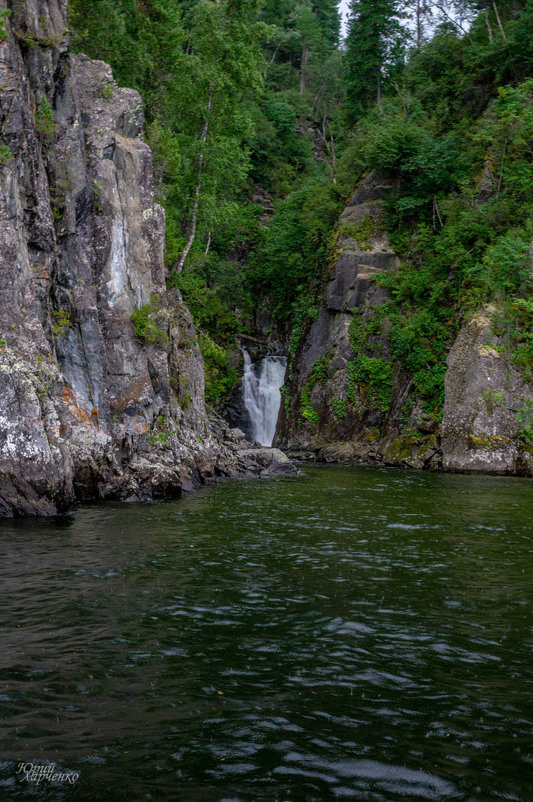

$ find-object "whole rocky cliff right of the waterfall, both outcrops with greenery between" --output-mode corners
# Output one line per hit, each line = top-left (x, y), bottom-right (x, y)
(276, 177), (533, 475)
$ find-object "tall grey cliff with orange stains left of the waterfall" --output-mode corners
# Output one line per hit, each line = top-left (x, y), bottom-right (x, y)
(0, 0), (288, 516)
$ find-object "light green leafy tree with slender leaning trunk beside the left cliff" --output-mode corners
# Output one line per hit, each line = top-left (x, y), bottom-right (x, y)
(169, 0), (266, 273)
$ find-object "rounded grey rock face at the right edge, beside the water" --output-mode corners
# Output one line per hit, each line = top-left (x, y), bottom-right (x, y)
(441, 306), (533, 475)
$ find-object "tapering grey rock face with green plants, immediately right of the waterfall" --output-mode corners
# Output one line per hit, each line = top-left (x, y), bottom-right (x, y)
(276, 172), (428, 467)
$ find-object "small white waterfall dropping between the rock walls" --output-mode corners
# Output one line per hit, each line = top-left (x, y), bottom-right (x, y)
(242, 348), (287, 446)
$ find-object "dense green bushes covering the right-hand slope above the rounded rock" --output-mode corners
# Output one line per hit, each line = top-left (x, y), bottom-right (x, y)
(332, 0), (533, 414)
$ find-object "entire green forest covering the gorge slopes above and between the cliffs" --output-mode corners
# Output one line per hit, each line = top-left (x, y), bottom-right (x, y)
(69, 0), (533, 417)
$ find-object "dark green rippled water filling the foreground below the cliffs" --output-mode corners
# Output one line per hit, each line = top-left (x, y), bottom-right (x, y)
(0, 468), (533, 802)
